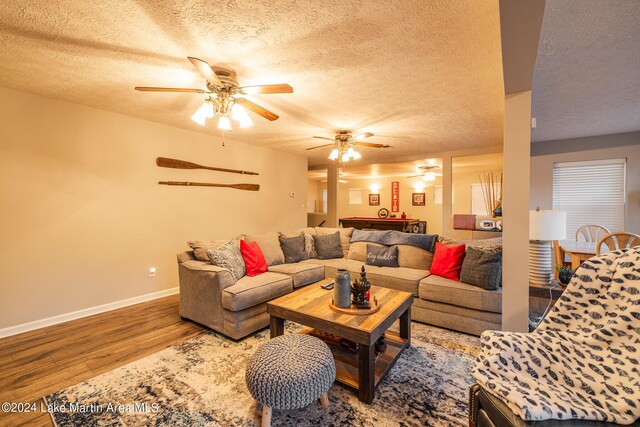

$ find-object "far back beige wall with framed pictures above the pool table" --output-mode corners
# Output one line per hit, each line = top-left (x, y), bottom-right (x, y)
(338, 177), (442, 234)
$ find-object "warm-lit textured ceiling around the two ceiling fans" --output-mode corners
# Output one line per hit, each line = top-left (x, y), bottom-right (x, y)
(0, 0), (504, 164)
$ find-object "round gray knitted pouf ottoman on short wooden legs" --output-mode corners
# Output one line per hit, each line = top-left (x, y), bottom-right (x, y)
(245, 334), (336, 427)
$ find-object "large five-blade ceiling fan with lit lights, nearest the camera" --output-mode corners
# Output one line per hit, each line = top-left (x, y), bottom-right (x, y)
(135, 56), (293, 130)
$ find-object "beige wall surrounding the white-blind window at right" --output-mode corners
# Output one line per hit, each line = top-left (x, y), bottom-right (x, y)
(529, 132), (640, 233)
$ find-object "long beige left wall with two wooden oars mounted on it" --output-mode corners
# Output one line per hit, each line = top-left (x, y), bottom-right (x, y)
(0, 89), (307, 329)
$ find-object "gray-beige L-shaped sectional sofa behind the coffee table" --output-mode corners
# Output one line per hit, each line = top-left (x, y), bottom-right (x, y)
(178, 227), (502, 340)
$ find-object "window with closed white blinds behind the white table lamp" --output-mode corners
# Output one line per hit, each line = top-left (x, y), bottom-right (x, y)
(553, 159), (626, 239)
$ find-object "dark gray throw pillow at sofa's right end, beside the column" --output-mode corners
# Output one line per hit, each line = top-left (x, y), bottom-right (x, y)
(460, 246), (502, 291)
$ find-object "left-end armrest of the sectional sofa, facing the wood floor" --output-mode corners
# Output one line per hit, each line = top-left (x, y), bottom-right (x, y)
(178, 260), (235, 331)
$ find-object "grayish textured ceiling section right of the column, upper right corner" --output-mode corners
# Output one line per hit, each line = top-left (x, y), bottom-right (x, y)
(532, 0), (640, 141)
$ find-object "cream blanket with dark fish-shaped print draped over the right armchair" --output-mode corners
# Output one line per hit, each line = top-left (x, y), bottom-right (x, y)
(473, 247), (640, 424)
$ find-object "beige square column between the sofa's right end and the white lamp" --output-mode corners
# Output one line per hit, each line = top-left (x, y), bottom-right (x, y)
(502, 91), (531, 332)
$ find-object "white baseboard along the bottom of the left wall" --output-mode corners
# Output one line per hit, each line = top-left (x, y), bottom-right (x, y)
(0, 286), (180, 338)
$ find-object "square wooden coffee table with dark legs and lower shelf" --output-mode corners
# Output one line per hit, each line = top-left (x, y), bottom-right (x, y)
(267, 279), (413, 403)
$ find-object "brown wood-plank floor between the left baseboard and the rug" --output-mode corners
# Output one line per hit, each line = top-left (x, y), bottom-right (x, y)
(0, 295), (203, 426)
